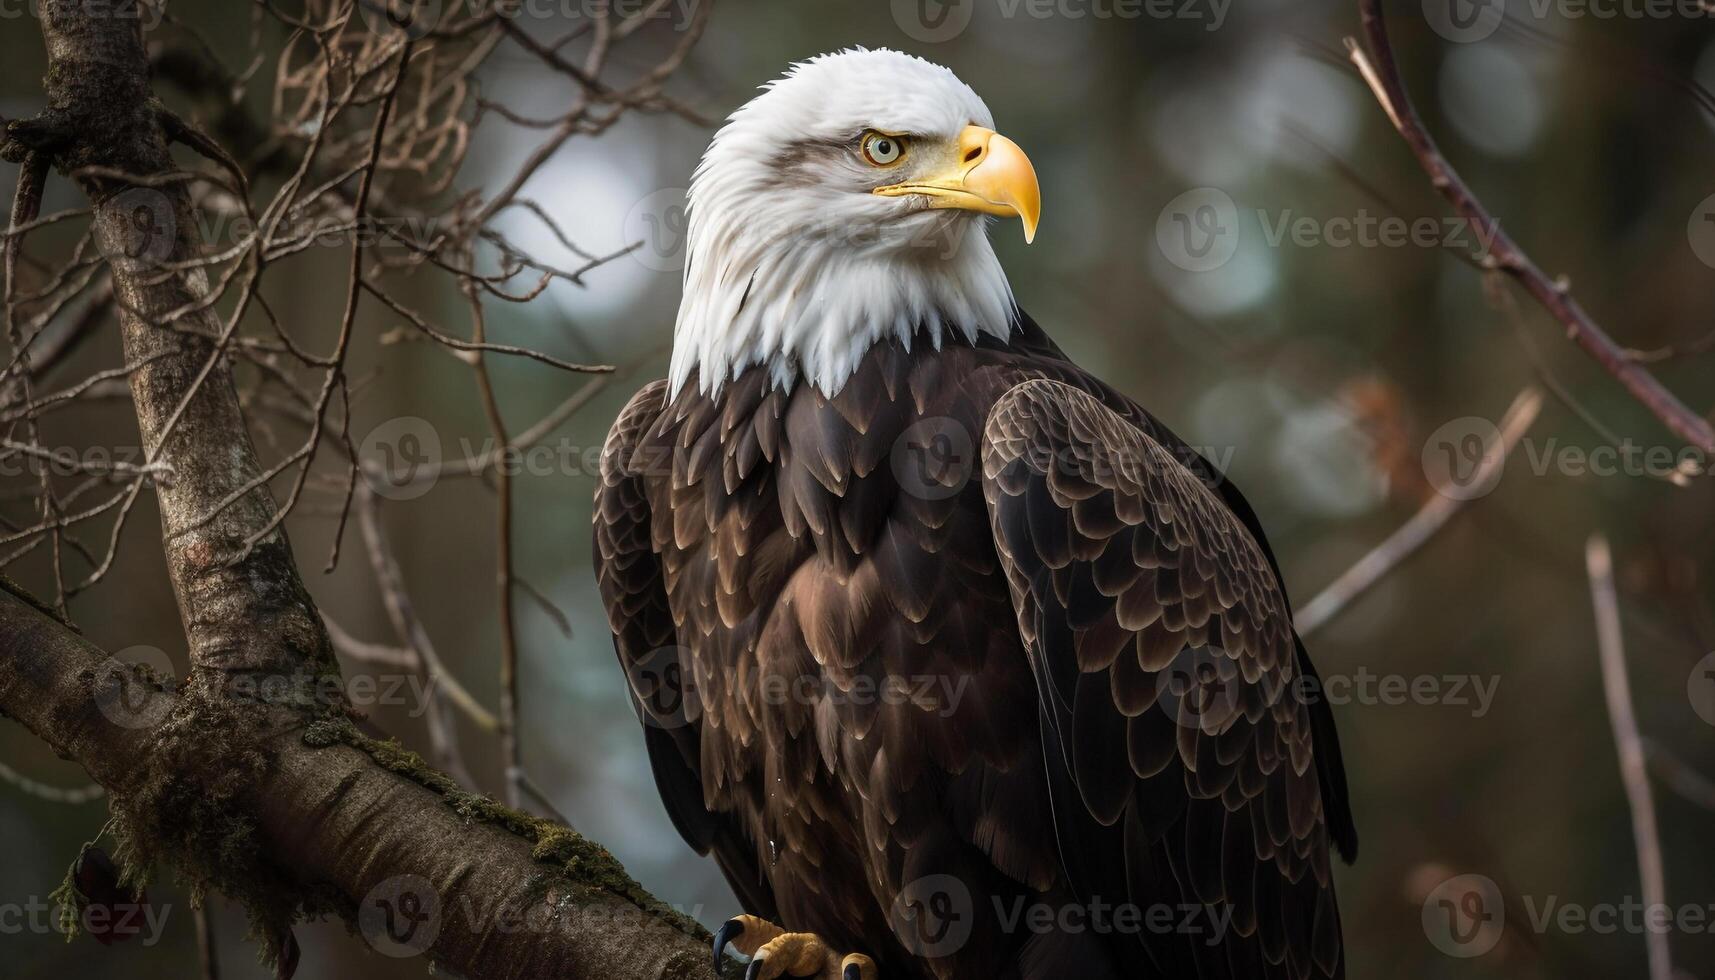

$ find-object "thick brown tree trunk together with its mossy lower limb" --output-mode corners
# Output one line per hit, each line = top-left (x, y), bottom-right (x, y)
(0, 0), (730, 980)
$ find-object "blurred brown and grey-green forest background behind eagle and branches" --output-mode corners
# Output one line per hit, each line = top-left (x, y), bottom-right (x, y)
(0, 0), (1715, 980)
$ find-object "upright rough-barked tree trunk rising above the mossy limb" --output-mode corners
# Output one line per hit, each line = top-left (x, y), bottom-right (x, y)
(34, 0), (338, 688)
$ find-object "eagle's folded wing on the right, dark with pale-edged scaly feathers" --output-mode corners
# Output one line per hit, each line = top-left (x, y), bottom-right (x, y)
(983, 379), (1345, 978)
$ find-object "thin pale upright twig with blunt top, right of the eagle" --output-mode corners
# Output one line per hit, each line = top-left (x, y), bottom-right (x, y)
(1585, 534), (1674, 980)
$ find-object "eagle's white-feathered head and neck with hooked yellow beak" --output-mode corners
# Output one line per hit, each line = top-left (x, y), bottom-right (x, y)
(671, 48), (1041, 396)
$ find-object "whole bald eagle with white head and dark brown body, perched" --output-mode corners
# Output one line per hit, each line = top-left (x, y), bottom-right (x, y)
(595, 50), (1357, 980)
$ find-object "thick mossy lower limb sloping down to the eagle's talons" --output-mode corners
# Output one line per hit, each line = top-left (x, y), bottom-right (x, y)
(0, 590), (730, 980)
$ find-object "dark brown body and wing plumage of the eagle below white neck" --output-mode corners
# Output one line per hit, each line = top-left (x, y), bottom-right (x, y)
(595, 316), (1357, 978)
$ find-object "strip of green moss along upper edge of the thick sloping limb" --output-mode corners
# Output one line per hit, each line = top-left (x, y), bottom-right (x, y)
(304, 719), (708, 941)
